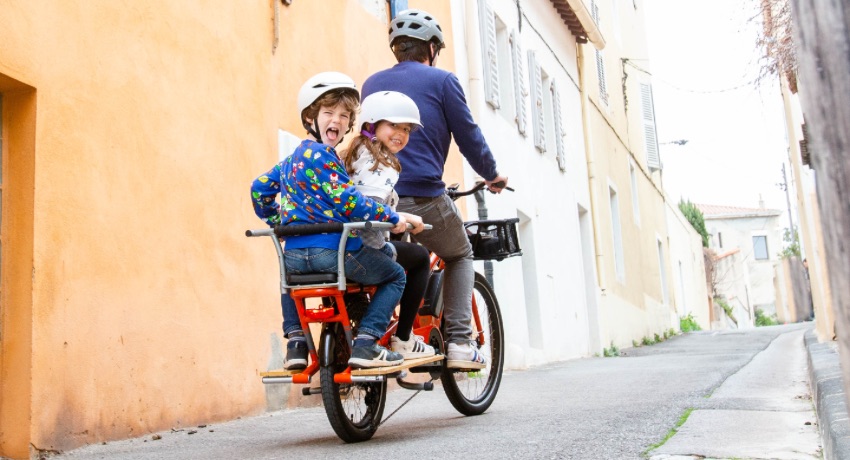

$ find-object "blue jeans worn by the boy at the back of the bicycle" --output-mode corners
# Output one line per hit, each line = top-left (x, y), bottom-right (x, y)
(280, 245), (405, 338)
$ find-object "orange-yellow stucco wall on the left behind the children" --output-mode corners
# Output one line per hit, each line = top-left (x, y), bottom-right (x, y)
(0, 0), (454, 458)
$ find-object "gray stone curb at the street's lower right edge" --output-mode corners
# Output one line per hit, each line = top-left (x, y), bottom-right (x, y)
(805, 329), (850, 460)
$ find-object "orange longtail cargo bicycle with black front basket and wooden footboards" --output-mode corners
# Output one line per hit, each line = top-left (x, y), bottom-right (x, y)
(245, 183), (522, 442)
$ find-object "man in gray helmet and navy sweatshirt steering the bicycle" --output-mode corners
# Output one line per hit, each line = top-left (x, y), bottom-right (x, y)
(362, 9), (508, 369)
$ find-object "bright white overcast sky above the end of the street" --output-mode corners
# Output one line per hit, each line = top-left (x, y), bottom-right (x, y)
(644, 0), (793, 221)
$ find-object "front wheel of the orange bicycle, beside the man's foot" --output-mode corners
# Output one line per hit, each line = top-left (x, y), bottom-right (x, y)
(440, 272), (505, 415)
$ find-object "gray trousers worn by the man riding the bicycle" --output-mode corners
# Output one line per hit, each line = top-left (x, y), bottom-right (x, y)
(397, 195), (475, 343)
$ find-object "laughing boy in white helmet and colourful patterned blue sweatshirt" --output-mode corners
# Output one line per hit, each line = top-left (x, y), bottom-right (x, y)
(251, 72), (422, 369)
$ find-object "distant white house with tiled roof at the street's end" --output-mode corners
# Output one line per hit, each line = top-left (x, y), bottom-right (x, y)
(697, 204), (787, 329)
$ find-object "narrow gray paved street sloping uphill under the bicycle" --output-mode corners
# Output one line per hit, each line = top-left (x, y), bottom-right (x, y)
(51, 323), (821, 459)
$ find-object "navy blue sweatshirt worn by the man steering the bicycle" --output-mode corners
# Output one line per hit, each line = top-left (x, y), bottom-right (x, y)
(362, 61), (498, 197)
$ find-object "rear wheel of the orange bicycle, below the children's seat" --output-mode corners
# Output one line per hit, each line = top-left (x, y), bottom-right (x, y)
(319, 325), (387, 443)
